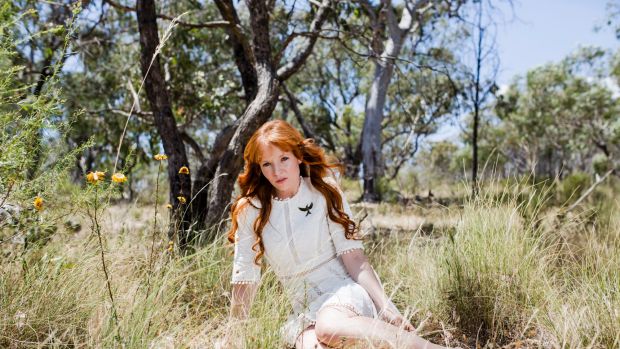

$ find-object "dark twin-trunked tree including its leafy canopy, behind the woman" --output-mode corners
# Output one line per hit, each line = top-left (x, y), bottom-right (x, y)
(37, 0), (339, 245)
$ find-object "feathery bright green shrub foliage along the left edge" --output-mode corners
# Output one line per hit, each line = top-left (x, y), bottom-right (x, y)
(0, 4), (86, 247)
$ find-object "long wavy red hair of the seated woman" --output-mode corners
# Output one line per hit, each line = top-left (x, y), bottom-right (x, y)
(228, 120), (359, 265)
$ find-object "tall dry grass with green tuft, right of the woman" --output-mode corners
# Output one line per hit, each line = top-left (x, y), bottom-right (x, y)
(372, 178), (620, 348)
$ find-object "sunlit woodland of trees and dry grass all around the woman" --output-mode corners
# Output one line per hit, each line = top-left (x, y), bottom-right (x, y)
(0, 0), (620, 348)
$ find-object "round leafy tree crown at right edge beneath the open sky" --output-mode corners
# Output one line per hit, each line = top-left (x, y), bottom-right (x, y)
(495, 48), (620, 178)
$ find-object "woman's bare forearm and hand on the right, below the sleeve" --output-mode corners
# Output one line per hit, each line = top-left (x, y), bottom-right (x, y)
(341, 249), (415, 331)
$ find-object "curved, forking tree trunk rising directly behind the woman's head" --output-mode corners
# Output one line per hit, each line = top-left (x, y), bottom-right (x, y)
(198, 0), (333, 242)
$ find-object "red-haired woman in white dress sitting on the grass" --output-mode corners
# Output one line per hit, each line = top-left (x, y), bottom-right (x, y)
(228, 120), (452, 348)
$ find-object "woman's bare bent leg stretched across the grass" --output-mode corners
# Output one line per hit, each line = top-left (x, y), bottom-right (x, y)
(315, 306), (452, 349)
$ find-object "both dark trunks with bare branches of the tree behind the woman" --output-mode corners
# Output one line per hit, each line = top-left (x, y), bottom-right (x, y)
(120, 0), (336, 242)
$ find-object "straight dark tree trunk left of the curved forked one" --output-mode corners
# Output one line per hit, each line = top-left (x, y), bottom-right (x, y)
(136, 0), (193, 248)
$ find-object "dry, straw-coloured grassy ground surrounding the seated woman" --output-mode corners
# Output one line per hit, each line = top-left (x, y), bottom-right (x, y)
(0, 179), (620, 348)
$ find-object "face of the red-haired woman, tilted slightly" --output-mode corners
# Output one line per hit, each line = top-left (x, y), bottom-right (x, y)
(259, 142), (301, 197)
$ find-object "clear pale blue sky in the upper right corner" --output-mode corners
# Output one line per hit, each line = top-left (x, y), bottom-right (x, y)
(497, 0), (620, 85)
